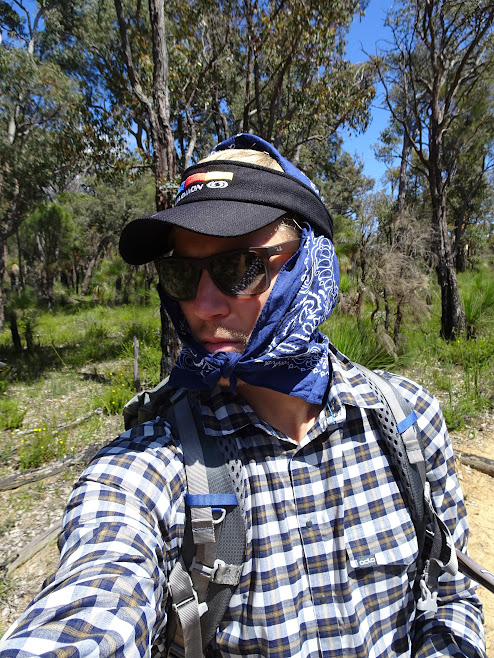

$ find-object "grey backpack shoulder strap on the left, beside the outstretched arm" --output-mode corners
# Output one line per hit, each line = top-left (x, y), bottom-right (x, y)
(167, 391), (246, 658)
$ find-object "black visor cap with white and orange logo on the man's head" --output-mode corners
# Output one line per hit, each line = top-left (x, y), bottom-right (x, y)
(120, 143), (333, 265)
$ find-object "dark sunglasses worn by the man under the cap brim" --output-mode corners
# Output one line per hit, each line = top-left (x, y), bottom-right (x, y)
(155, 239), (300, 302)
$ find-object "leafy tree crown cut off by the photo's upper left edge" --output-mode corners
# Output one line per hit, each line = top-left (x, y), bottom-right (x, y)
(0, 0), (85, 329)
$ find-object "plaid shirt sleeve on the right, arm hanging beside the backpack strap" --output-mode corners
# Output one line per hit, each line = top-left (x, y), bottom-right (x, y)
(384, 377), (486, 658)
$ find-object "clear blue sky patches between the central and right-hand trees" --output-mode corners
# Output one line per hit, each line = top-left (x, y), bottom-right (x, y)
(342, 0), (393, 188)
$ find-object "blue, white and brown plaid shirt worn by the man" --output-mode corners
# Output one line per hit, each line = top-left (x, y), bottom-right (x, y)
(0, 351), (485, 658)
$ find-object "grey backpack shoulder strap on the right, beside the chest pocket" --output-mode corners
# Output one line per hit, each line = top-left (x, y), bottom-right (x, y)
(354, 364), (458, 612)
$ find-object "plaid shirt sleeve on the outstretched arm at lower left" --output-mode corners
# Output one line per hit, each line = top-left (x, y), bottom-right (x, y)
(0, 421), (185, 658)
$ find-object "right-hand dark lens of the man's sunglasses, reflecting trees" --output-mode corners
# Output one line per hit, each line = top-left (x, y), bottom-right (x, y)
(211, 252), (266, 297)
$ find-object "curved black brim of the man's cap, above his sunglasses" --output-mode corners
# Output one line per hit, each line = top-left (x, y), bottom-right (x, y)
(119, 200), (287, 265)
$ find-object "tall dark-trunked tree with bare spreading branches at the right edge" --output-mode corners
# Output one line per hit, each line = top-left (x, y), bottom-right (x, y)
(374, 0), (494, 339)
